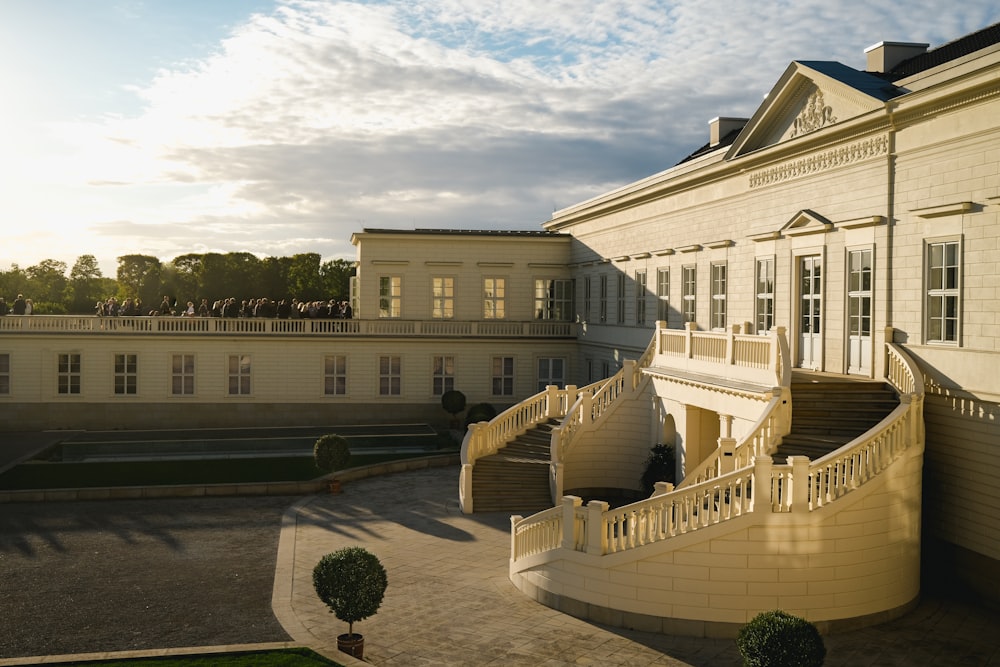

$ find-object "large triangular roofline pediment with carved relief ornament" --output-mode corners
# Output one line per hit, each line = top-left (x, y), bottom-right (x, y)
(726, 61), (905, 159)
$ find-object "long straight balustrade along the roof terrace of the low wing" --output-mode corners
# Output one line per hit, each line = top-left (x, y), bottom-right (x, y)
(0, 315), (576, 338)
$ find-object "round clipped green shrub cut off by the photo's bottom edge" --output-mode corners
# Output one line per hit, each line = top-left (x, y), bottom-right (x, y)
(736, 609), (826, 667)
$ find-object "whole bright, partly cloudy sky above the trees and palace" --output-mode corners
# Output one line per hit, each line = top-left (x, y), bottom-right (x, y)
(0, 0), (1000, 277)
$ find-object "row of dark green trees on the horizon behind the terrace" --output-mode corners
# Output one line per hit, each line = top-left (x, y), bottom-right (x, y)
(0, 252), (354, 315)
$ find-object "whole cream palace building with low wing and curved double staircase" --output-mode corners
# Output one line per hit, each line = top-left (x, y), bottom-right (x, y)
(0, 24), (1000, 635)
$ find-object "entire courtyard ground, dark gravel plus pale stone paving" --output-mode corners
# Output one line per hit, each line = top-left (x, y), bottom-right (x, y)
(0, 467), (1000, 667)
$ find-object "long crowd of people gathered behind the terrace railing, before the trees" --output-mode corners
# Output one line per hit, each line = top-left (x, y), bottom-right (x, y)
(94, 296), (354, 319)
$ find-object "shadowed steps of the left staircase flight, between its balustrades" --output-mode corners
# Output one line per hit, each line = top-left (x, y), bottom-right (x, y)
(472, 419), (559, 515)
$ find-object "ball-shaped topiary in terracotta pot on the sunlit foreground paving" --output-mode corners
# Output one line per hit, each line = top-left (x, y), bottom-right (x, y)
(313, 547), (389, 658)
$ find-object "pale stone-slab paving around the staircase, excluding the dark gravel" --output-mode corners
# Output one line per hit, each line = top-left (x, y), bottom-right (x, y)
(273, 468), (1000, 667)
